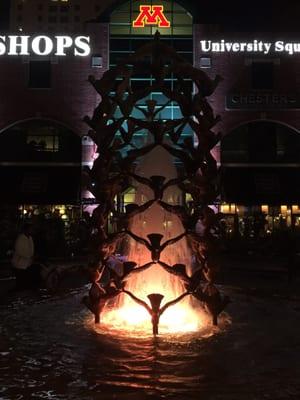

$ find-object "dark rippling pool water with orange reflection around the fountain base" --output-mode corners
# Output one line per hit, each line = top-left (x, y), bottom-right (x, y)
(0, 288), (300, 400)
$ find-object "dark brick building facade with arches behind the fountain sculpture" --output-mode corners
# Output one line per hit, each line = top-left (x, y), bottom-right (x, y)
(0, 0), (300, 256)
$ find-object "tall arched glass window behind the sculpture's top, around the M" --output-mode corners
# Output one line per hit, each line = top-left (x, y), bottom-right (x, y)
(109, 0), (193, 147)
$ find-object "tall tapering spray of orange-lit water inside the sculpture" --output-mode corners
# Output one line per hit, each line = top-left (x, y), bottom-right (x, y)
(111, 146), (203, 332)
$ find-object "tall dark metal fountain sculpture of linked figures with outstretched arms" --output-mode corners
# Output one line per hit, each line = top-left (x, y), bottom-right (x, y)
(83, 33), (229, 335)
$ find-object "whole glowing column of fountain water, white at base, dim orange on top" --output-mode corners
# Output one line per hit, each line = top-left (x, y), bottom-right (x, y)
(101, 148), (209, 335)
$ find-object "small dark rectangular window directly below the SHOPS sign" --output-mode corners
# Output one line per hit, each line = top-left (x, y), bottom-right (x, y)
(28, 61), (51, 89)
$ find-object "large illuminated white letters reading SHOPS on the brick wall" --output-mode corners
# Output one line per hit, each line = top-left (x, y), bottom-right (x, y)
(0, 35), (91, 57)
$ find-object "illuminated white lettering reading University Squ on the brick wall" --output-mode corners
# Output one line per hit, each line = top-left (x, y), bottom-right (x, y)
(200, 39), (300, 55)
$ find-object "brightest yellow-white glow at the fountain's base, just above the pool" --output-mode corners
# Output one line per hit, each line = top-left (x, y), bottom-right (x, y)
(102, 265), (207, 333)
